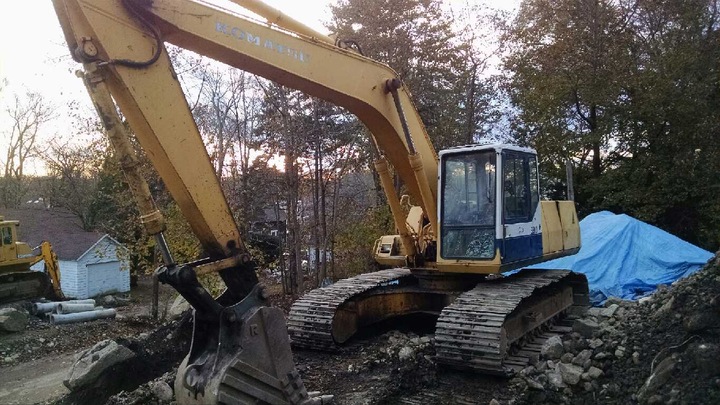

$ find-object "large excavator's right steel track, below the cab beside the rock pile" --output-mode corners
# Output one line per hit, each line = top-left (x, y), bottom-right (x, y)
(435, 270), (588, 376)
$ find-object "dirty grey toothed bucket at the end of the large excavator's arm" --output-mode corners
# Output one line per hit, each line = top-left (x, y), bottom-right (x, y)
(158, 264), (332, 405)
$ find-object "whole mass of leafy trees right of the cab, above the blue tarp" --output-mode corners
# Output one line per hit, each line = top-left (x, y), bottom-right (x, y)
(506, 0), (720, 250)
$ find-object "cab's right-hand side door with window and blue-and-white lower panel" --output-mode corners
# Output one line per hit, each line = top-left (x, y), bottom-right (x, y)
(499, 150), (542, 264)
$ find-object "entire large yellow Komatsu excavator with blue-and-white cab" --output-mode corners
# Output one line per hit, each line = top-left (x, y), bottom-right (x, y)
(53, 0), (587, 404)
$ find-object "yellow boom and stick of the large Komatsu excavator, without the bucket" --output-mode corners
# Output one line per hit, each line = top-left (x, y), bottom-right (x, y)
(54, 0), (437, 252)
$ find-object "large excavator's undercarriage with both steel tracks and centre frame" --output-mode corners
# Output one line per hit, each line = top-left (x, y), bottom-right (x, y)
(288, 268), (589, 376)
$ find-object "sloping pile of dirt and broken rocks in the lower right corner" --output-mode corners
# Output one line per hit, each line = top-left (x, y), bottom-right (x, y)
(512, 252), (720, 404)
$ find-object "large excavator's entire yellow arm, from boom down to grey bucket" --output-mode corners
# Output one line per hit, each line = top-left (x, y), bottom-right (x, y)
(53, 0), (437, 404)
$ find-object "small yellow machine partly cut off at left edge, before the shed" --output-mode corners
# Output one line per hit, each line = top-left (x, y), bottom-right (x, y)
(0, 216), (65, 304)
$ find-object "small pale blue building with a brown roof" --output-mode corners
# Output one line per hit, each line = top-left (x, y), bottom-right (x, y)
(0, 207), (130, 298)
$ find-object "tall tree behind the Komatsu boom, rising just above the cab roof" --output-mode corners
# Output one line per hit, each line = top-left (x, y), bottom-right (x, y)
(328, 0), (470, 149)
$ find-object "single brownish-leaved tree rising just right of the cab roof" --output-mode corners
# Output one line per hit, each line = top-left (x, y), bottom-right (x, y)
(505, 0), (628, 176)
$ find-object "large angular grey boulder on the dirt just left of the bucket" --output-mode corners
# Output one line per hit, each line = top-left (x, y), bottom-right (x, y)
(63, 340), (135, 391)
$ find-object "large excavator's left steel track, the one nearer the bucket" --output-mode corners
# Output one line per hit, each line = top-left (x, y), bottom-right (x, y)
(287, 268), (413, 350)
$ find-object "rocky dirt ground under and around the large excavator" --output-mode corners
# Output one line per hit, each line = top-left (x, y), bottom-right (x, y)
(0, 259), (720, 405)
